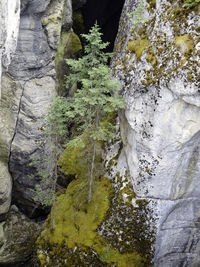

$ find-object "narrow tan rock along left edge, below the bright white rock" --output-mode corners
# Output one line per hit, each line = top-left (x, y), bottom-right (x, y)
(0, 74), (18, 218)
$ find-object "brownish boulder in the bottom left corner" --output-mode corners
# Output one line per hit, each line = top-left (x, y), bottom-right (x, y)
(0, 210), (39, 266)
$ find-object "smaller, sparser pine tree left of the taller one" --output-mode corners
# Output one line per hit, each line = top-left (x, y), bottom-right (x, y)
(30, 97), (69, 229)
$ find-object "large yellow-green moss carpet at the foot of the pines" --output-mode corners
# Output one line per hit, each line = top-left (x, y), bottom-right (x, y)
(37, 175), (151, 267)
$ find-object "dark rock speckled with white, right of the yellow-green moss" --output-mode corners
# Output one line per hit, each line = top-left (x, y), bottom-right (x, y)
(99, 174), (154, 266)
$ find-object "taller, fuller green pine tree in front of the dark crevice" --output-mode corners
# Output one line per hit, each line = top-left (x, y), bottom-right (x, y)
(66, 24), (125, 202)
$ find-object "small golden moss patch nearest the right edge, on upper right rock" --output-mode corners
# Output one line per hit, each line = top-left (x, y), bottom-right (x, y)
(175, 34), (194, 54)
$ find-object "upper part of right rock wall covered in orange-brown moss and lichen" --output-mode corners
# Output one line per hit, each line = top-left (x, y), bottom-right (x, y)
(114, 0), (200, 88)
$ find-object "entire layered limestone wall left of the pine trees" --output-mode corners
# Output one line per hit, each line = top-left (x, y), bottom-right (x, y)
(0, 0), (72, 217)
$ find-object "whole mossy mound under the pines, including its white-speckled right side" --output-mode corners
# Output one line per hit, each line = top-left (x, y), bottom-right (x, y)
(37, 172), (152, 267)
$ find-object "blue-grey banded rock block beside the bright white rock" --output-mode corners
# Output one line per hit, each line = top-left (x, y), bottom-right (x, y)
(9, 14), (53, 79)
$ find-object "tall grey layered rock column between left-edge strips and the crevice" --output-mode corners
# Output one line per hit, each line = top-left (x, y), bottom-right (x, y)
(8, 0), (68, 217)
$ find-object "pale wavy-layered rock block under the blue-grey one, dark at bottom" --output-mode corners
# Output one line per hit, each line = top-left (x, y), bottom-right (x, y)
(9, 76), (56, 217)
